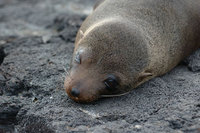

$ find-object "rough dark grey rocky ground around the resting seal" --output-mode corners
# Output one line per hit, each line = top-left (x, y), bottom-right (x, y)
(0, 0), (200, 133)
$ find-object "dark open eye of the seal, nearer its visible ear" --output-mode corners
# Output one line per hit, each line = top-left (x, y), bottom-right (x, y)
(104, 75), (119, 91)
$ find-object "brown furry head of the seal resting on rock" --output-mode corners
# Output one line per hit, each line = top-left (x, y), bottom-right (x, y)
(65, 19), (152, 102)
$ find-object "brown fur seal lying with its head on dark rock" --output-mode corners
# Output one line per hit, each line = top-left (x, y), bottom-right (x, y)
(65, 0), (200, 102)
